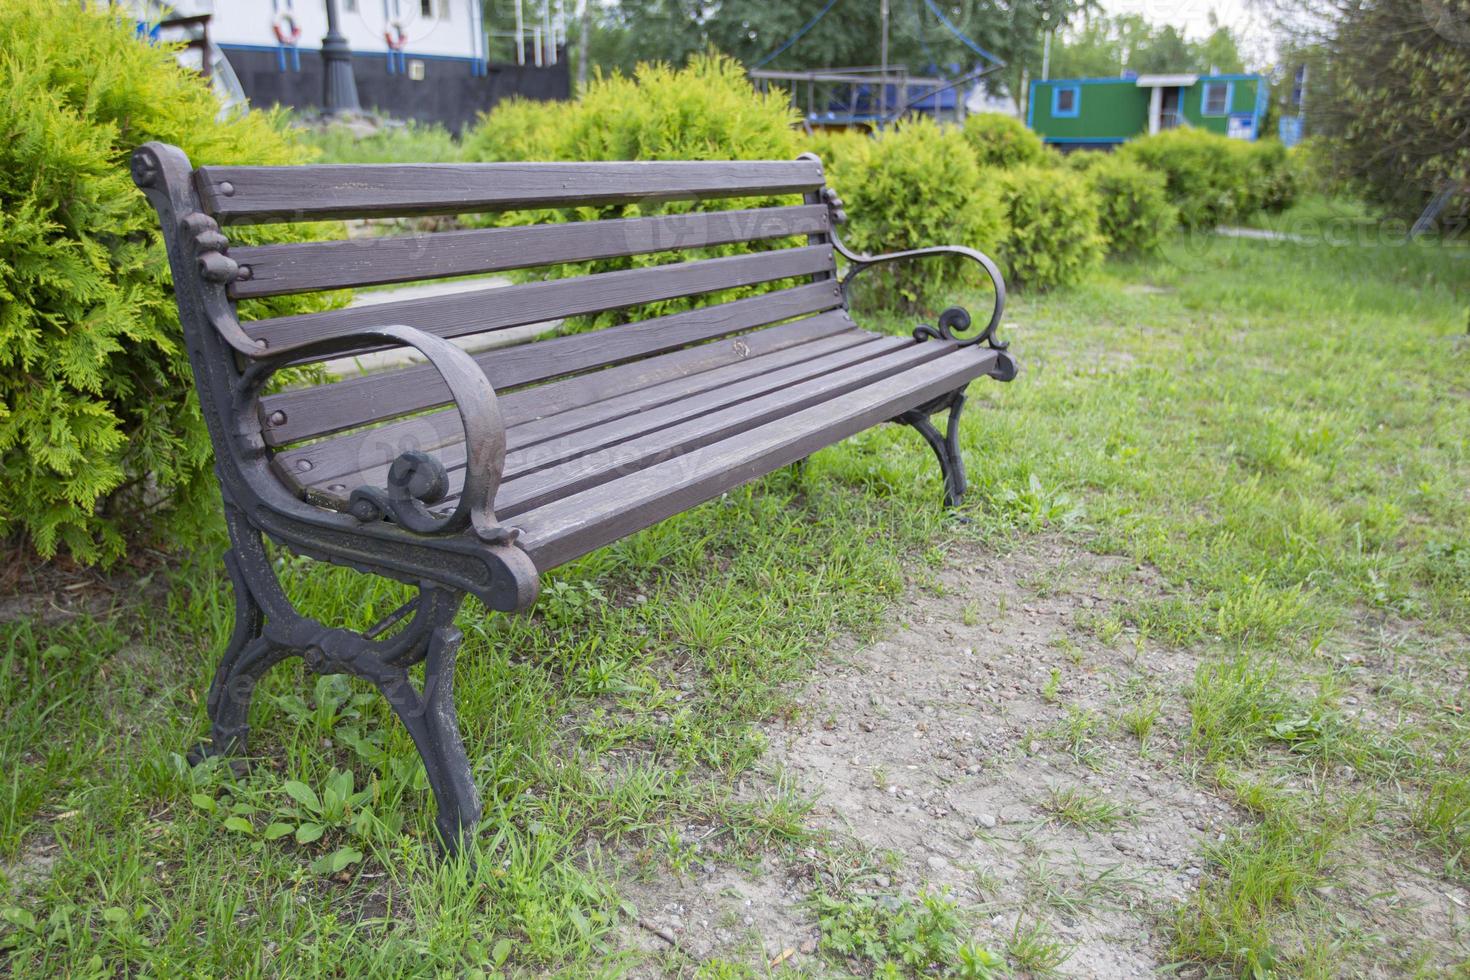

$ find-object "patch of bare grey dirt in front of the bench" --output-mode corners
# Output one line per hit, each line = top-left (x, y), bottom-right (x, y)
(611, 542), (1236, 977)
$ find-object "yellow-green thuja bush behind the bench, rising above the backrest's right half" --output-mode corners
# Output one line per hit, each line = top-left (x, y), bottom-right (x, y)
(465, 54), (801, 331)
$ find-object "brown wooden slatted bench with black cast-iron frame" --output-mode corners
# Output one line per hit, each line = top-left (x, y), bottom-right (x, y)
(132, 143), (1016, 851)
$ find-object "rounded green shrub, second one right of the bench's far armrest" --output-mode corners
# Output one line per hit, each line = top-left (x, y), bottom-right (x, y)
(992, 166), (1104, 289)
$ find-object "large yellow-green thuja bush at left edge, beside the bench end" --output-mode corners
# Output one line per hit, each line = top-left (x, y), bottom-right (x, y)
(0, 0), (331, 563)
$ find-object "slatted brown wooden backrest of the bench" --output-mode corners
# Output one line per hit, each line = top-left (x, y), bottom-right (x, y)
(168, 159), (842, 447)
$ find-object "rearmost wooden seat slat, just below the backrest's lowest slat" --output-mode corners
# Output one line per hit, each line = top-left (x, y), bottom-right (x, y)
(273, 310), (856, 491)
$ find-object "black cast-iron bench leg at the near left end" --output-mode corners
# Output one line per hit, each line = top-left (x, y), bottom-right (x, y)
(190, 504), (481, 854)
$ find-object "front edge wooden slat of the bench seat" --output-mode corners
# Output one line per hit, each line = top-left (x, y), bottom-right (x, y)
(510, 347), (997, 572)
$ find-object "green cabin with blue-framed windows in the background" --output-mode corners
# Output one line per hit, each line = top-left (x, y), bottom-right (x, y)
(1026, 73), (1267, 150)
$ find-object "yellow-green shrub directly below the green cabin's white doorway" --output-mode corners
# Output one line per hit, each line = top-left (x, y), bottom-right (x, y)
(1119, 128), (1252, 229)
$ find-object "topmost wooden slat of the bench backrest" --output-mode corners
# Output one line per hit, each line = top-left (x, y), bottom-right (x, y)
(194, 160), (822, 223)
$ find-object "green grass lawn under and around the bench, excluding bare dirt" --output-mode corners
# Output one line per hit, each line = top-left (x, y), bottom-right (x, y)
(0, 218), (1470, 976)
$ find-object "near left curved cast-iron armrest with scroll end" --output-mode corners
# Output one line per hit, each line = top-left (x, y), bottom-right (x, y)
(238, 325), (516, 545)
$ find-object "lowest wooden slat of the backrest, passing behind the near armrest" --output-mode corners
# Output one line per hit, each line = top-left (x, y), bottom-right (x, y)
(262, 282), (842, 445)
